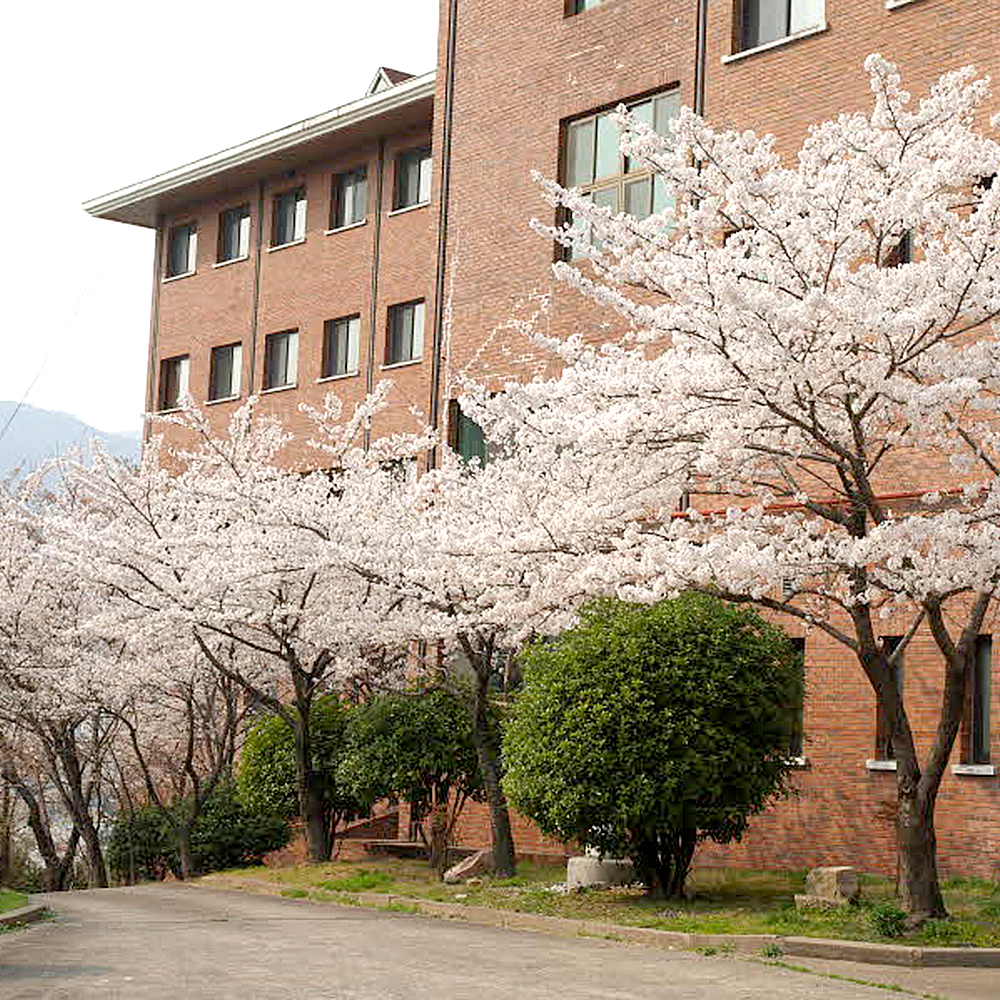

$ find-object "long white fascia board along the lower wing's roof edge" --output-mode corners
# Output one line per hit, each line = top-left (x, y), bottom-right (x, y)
(83, 71), (436, 226)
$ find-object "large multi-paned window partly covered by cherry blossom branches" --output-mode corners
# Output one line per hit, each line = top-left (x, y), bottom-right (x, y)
(563, 90), (680, 256)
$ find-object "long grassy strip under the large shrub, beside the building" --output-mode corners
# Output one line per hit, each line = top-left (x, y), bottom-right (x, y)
(211, 859), (1000, 947)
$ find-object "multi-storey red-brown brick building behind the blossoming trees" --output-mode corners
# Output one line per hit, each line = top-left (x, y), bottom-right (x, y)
(85, 0), (1000, 878)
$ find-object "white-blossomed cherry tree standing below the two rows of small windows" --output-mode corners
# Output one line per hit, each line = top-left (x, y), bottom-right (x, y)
(51, 387), (424, 861)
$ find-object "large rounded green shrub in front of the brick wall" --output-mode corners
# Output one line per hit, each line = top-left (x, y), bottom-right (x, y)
(503, 594), (801, 896)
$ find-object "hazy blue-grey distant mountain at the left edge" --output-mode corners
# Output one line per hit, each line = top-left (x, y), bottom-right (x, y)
(0, 400), (142, 479)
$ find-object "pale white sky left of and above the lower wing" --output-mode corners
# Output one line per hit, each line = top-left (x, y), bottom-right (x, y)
(0, 0), (438, 431)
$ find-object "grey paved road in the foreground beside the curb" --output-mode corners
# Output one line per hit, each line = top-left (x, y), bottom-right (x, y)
(0, 884), (976, 1000)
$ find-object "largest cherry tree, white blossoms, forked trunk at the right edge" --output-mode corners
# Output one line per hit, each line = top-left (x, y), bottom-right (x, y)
(472, 56), (1000, 919)
